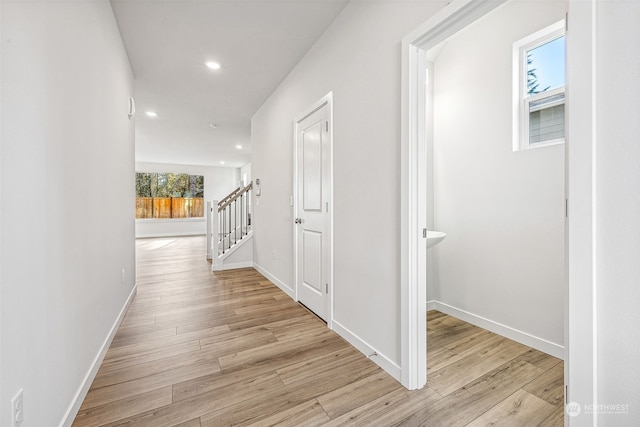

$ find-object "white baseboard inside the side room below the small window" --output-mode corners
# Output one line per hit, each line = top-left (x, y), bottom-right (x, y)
(427, 300), (564, 360)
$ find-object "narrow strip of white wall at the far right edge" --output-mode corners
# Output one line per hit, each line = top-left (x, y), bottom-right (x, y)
(596, 1), (640, 426)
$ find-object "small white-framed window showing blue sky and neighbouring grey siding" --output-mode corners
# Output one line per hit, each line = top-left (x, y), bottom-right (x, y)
(513, 20), (566, 151)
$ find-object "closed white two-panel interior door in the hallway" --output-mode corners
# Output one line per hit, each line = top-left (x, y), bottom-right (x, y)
(294, 97), (332, 322)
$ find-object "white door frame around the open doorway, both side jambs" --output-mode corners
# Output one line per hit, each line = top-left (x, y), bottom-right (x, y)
(400, 0), (598, 418)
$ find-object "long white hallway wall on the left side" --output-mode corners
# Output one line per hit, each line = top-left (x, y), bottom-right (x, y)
(0, 1), (135, 427)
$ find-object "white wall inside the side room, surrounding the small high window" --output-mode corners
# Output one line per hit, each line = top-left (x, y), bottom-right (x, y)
(427, 1), (566, 356)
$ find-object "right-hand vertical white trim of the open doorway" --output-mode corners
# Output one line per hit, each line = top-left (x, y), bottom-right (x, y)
(565, 0), (598, 426)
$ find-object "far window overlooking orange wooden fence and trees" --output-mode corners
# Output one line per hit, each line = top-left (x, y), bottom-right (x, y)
(136, 172), (204, 219)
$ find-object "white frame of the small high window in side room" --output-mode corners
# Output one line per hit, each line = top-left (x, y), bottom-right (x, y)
(512, 19), (567, 151)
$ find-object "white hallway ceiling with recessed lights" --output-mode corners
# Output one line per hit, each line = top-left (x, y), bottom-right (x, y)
(111, 0), (348, 167)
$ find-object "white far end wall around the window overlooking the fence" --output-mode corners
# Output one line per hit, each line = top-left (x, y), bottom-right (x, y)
(136, 162), (240, 237)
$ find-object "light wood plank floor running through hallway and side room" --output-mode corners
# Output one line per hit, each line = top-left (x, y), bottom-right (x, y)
(73, 237), (563, 427)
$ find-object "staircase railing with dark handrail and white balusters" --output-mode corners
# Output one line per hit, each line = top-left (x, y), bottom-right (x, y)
(207, 183), (253, 271)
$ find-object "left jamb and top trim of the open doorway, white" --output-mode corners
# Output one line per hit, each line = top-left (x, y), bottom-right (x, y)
(400, 0), (506, 390)
